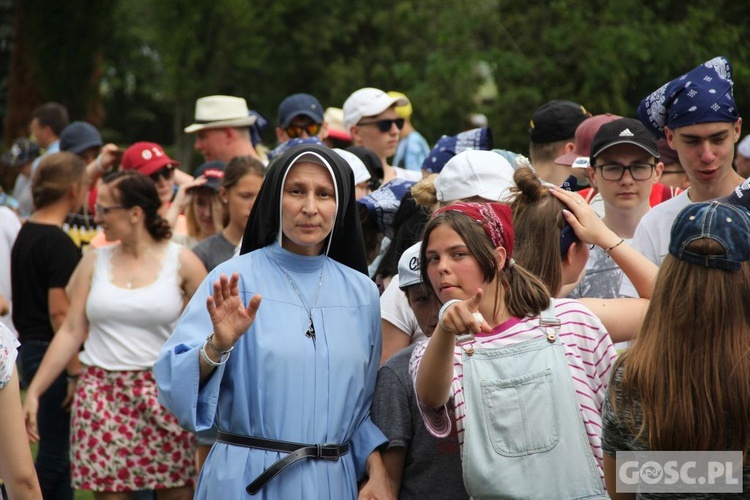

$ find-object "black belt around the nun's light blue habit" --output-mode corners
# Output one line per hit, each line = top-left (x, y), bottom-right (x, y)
(216, 431), (349, 495)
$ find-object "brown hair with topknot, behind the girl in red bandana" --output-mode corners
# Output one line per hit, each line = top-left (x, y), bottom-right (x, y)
(511, 168), (565, 295)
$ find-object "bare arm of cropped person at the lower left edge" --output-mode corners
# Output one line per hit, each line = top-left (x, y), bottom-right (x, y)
(0, 370), (42, 500)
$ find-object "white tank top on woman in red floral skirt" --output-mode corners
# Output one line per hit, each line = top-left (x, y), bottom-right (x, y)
(79, 242), (184, 371)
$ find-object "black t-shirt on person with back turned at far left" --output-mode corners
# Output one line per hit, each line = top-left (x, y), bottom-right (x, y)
(10, 221), (81, 343)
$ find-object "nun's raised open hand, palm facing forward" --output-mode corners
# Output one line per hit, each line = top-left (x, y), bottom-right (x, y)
(206, 273), (261, 351)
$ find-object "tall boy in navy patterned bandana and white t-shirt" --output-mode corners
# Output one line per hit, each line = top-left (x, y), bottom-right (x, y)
(621, 57), (743, 296)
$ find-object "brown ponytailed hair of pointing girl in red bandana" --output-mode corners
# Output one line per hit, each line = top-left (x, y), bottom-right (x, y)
(419, 211), (550, 318)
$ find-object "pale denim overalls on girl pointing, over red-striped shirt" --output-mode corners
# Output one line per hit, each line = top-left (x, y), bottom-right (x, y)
(459, 304), (606, 499)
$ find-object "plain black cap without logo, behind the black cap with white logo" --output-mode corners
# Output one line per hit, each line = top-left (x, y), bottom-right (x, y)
(529, 101), (591, 144)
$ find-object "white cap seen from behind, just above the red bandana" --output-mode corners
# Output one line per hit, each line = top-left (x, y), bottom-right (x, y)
(435, 149), (516, 202)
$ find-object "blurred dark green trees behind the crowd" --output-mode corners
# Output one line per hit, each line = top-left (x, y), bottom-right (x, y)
(0, 0), (750, 182)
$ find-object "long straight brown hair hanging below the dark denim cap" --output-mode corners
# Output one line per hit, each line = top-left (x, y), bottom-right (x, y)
(610, 239), (750, 463)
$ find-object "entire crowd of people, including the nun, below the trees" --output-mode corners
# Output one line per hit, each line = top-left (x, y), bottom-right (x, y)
(0, 57), (750, 500)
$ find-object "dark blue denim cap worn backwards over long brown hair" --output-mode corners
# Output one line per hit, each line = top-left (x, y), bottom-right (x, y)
(669, 200), (750, 271)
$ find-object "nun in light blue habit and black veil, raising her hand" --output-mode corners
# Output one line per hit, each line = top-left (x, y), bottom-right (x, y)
(154, 144), (386, 499)
